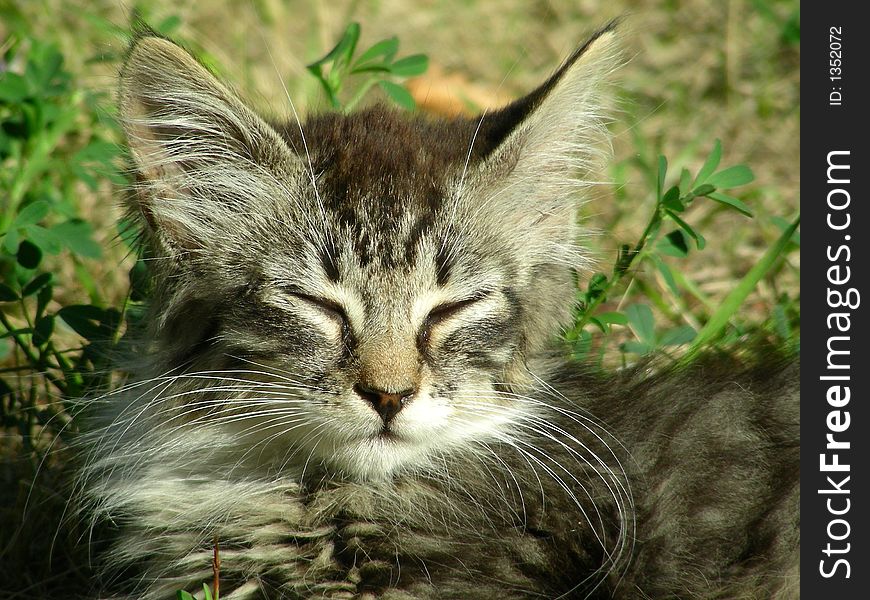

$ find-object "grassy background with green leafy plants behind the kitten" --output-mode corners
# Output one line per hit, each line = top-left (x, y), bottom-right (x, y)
(0, 0), (800, 598)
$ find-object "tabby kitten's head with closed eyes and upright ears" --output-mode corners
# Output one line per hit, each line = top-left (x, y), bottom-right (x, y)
(120, 28), (617, 479)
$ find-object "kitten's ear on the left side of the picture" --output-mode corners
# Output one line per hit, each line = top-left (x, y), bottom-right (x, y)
(120, 32), (302, 251)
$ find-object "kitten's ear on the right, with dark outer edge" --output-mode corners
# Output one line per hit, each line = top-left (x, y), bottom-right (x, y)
(467, 22), (621, 243)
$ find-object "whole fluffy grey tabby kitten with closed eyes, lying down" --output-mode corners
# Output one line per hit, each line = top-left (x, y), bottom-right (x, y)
(79, 21), (799, 600)
